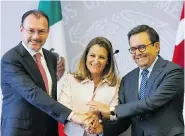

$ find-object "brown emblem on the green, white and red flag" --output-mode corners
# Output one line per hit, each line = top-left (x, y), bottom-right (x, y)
(57, 57), (65, 81)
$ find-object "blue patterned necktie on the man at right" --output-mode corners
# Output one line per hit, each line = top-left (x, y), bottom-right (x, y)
(140, 69), (149, 99)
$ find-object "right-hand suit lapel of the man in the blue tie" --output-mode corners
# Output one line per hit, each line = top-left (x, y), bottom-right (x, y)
(145, 56), (166, 97)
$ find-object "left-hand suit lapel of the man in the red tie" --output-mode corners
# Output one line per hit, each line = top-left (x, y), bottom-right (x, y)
(17, 43), (45, 90)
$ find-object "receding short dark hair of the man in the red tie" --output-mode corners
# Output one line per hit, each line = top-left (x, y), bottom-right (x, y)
(21, 9), (49, 28)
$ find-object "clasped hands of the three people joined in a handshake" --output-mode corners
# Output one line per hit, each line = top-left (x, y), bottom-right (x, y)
(71, 101), (110, 134)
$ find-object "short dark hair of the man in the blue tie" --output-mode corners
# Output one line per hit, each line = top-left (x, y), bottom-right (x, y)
(127, 25), (159, 43)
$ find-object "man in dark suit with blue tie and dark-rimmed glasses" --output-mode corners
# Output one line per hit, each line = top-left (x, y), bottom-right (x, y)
(91, 25), (184, 136)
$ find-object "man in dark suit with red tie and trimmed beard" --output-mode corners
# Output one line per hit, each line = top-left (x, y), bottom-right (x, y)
(1, 10), (92, 136)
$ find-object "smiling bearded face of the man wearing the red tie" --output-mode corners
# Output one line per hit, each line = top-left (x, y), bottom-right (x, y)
(20, 14), (49, 51)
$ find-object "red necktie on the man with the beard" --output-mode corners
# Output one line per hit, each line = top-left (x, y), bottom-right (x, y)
(35, 53), (49, 92)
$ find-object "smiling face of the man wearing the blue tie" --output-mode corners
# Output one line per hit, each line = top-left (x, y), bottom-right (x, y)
(129, 32), (160, 70)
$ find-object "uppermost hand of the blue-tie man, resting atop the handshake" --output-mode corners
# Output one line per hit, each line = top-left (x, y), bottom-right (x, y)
(88, 101), (110, 120)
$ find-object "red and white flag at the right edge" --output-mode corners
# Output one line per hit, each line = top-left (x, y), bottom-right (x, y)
(172, 2), (185, 68)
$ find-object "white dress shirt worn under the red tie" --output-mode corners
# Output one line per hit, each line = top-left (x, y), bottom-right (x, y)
(22, 42), (52, 96)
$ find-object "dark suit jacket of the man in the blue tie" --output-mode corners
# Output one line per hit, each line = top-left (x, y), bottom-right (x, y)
(105, 56), (184, 136)
